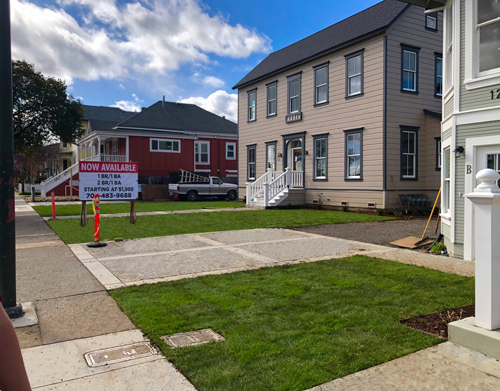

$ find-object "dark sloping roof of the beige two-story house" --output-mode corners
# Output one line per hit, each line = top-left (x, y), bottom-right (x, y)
(233, 0), (409, 89)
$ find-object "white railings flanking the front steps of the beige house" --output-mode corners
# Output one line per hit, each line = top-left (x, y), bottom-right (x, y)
(246, 168), (304, 207)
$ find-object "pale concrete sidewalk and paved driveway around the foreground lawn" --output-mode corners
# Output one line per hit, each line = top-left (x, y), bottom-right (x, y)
(11, 198), (500, 391)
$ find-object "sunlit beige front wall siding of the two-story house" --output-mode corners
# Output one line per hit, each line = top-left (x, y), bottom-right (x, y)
(238, 35), (384, 207)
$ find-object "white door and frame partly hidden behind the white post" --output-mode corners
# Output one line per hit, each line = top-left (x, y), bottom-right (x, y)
(464, 136), (500, 261)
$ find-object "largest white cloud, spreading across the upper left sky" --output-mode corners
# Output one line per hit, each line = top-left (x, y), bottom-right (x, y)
(11, 0), (271, 83)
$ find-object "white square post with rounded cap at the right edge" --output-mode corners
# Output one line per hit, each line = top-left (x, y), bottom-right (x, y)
(465, 168), (500, 330)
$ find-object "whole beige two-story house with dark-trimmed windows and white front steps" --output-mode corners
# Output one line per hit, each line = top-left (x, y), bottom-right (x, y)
(233, 0), (443, 209)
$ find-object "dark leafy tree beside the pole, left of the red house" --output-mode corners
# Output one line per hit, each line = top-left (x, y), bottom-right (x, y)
(12, 61), (83, 157)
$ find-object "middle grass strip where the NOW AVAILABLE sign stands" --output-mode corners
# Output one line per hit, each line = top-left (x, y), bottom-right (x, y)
(48, 208), (391, 244)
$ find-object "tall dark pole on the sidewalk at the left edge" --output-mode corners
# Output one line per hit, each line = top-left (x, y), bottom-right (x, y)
(0, 0), (23, 318)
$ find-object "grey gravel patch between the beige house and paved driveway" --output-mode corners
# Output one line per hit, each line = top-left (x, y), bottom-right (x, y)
(292, 218), (439, 249)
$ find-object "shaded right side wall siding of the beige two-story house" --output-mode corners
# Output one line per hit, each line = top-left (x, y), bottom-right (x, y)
(386, 7), (443, 209)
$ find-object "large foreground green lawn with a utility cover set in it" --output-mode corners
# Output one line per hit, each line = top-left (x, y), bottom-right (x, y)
(110, 256), (474, 391)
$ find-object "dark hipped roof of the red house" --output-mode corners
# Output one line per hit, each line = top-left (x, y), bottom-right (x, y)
(118, 101), (238, 135)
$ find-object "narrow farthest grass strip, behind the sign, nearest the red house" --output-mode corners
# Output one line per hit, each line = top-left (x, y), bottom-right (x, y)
(33, 201), (245, 217)
